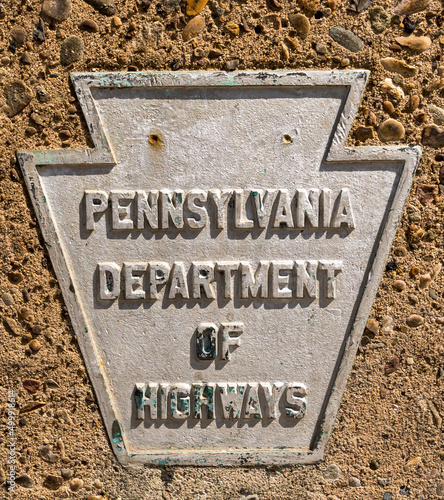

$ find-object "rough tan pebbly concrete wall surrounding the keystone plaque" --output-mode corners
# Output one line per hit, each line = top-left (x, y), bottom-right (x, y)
(0, 0), (444, 500)
